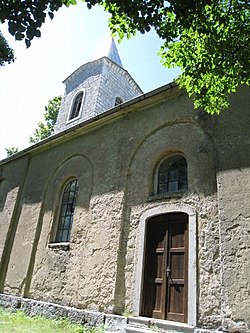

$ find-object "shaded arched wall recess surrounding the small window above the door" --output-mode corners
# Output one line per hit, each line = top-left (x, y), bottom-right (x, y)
(127, 122), (216, 204)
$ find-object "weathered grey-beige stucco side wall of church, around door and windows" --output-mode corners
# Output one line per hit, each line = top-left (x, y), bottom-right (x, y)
(0, 87), (250, 332)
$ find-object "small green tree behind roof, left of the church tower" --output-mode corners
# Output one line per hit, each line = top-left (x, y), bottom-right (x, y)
(29, 96), (62, 144)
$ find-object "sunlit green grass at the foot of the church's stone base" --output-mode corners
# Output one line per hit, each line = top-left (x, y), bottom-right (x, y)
(0, 308), (100, 333)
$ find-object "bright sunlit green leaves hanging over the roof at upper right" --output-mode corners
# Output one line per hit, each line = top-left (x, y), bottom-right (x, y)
(159, 1), (250, 114)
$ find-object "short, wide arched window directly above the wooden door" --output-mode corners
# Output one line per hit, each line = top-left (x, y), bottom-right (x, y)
(157, 155), (188, 194)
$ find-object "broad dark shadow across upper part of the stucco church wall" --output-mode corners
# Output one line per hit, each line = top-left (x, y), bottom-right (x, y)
(0, 87), (250, 210)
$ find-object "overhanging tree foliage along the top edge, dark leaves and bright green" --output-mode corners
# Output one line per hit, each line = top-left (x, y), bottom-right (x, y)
(0, 0), (250, 113)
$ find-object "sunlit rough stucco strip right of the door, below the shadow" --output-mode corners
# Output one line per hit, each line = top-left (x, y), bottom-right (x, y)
(218, 169), (250, 332)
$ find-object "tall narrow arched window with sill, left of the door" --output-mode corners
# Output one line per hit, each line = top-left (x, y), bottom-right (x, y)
(55, 179), (78, 243)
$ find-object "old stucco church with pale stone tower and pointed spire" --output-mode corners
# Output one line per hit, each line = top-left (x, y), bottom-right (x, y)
(0, 40), (250, 333)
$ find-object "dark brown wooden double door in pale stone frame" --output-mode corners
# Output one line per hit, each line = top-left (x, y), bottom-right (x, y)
(141, 213), (188, 322)
